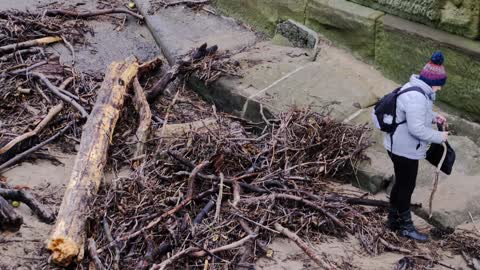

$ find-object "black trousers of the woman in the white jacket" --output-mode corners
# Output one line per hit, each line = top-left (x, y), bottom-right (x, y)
(388, 152), (418, 213)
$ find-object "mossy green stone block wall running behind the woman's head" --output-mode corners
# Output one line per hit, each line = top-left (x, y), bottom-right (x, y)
(214, 0), (480, 122)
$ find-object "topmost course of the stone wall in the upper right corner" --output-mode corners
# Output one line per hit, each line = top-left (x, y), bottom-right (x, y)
(349, 0), (480, 39)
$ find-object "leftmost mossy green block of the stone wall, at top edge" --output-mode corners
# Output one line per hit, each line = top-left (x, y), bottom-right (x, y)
(213, 0), (307, 36)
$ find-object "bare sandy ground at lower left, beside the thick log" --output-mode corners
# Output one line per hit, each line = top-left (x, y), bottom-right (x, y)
(0, 153), (75, 270)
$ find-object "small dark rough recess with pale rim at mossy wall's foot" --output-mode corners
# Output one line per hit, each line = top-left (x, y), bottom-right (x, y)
(276, 20), (318, 49)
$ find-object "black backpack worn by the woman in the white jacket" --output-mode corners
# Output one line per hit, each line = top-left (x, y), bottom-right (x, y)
(373, 86), (425, 136)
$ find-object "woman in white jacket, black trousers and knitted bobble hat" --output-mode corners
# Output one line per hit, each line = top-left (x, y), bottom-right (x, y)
(384, 52), (448, 241)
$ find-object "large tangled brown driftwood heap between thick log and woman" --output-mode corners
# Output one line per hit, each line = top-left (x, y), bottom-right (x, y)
(82, 95), (480, 269)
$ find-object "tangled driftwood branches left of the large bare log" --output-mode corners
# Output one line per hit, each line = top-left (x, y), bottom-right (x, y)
(0, 6), (143, 236)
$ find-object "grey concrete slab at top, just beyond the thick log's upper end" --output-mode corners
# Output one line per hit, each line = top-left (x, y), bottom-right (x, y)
(135, 0), (257, 61)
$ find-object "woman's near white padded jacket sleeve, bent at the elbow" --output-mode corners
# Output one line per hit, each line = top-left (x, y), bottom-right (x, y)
(405, 92), (443, 143)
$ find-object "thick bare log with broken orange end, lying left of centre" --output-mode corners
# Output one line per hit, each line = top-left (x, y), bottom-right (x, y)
(47, 58), (138, 266)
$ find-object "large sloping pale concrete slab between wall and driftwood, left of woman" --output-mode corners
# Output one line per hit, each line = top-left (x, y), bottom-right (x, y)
(250, 46), (396, 120)
